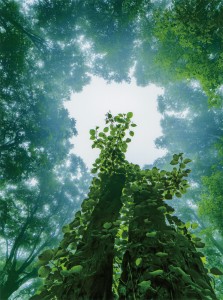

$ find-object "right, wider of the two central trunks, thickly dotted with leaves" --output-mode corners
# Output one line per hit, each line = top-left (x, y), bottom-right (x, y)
(119, 179), (217, 300)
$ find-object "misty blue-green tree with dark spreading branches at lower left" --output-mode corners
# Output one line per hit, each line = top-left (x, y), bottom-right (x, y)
(0, 156), (88, 299)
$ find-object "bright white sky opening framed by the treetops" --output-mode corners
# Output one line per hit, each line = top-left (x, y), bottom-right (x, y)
(65, 77), (164, 168)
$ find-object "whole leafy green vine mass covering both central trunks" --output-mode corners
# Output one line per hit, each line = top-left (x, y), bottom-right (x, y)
(32, 112), (216, 300)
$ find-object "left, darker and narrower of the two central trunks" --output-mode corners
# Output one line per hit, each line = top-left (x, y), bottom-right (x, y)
(62, 174), (125, 300)
